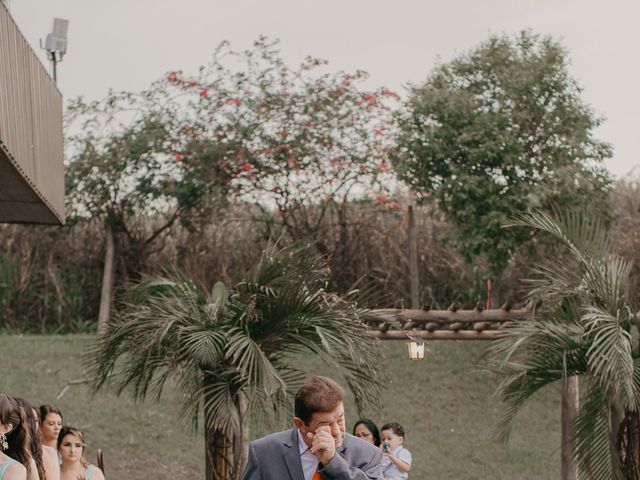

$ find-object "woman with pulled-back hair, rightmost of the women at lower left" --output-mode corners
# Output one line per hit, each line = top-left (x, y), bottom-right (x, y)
(58, 425), (104, 480)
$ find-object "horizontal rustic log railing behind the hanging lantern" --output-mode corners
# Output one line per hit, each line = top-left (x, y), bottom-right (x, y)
(366, 303), (533, 340)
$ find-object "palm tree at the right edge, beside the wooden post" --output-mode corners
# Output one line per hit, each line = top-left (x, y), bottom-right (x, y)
(487, 211), (640, 480)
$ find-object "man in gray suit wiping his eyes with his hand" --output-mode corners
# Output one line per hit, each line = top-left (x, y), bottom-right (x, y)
(242, 377), (383, 480)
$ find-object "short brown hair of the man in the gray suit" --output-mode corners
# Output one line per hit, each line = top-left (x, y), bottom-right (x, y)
(295, 376), (344, 425)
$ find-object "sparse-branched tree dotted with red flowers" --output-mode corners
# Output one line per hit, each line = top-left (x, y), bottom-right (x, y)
(160, 38), (398, 251)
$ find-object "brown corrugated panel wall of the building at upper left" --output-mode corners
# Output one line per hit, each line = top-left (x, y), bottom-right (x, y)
(0, 4), (65, 223)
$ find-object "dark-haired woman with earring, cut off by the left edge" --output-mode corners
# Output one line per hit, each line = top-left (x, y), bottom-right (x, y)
(0, 393), (29, 480)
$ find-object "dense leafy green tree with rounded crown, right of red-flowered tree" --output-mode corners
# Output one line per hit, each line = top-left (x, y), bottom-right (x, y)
(394, 31), (611, 274)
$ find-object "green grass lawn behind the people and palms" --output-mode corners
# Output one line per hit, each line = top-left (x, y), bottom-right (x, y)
(0, 334), (560, 480)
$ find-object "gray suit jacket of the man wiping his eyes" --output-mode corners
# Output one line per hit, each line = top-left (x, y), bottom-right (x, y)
(242, 428), (383, 480)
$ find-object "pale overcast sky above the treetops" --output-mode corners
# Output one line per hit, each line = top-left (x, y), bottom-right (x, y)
(8, 0), (640, 176)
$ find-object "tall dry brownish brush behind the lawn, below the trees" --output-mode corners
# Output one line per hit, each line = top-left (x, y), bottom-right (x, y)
(0, 180), (640, 332)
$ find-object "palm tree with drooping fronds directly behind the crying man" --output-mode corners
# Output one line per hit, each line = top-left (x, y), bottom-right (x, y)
(87, 246), (382, 479)
